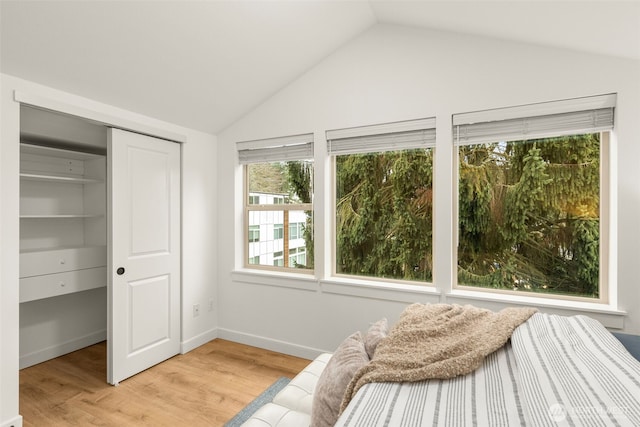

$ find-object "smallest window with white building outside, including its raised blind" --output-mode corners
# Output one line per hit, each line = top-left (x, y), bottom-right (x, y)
(237, 134), (313, 272)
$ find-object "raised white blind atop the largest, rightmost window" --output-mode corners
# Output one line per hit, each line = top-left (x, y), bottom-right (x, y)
(453, 94), (616, 145)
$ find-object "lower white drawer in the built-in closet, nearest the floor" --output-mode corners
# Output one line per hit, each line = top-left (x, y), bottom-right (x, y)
(20, 267), (107, 302)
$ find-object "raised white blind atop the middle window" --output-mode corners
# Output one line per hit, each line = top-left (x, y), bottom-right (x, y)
(326, 117), (436, 156)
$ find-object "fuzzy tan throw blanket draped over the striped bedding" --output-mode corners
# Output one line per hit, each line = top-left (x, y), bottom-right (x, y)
(340, 304), (537, 413)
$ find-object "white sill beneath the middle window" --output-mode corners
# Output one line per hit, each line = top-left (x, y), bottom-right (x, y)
(320, 277), (441, 304)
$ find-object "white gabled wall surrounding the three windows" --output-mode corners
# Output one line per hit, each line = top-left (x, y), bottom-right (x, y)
(218, 25), (640, 357)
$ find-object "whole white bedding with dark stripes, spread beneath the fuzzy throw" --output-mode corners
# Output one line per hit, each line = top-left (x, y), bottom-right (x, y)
(336, 313), (640, 427)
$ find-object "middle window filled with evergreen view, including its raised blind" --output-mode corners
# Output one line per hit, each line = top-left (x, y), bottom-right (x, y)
(327, 118), (435, 282)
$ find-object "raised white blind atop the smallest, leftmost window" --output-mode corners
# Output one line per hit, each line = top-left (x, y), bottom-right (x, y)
(236, 133), (313, 165)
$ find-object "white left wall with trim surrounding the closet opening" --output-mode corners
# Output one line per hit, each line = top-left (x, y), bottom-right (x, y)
(0, 75), (217, 427)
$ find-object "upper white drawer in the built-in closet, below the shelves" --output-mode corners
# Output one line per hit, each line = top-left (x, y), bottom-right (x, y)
(20, 246), (107, 277)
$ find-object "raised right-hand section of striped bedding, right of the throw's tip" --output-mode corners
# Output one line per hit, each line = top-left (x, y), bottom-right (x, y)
(511, 314), (640, 426)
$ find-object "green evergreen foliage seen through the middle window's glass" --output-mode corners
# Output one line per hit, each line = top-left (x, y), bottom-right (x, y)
(336, 150), (433, 281)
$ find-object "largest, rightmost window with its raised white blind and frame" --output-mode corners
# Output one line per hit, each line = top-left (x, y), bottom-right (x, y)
(453, 95), (615, 301)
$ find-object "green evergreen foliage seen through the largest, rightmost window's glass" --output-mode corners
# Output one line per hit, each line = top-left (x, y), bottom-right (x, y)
(458, 134), (600, 297)
